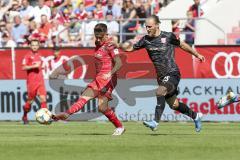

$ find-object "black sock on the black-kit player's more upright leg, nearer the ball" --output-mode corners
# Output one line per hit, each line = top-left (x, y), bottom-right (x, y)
(154, 96), (165, 123)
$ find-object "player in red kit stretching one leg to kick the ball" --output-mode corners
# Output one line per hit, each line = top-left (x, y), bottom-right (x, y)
(53, 23), (125, 136)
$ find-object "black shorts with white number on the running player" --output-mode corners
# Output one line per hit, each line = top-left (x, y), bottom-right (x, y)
(157, 72), (181, 99)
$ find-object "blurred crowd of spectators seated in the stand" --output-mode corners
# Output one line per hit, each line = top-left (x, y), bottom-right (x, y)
(0, 0), (203, 47)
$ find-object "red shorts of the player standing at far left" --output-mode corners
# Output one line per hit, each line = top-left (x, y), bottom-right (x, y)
(27, 84), (47, 99)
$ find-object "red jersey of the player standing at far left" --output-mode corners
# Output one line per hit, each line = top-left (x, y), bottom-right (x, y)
(22, 52), (44, 84)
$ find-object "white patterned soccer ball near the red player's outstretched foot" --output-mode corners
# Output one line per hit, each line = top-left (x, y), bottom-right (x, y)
(35, 108), (52, 124)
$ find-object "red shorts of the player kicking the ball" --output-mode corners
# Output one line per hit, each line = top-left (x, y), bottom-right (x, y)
(87, 75), (117, 100)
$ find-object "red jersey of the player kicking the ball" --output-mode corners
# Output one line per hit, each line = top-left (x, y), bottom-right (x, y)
(95, 40), (119, 75)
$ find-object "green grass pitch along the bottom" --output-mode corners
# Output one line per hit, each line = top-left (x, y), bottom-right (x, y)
(0, 122), (240, 160)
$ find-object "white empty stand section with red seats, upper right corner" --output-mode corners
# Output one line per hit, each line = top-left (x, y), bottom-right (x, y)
(195, 0), (240, 45)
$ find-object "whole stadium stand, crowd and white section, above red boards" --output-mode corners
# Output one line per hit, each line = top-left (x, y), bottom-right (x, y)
(0, 0), (240, 47)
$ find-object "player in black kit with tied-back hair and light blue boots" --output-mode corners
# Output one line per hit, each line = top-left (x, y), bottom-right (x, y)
(121, 15), (205, 132)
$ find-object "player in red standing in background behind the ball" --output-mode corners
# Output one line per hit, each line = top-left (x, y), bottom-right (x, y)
(22, 40), (47, 124)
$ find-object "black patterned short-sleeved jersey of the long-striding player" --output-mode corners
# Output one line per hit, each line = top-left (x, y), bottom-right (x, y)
(133, 31), (180, 77)
